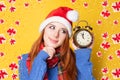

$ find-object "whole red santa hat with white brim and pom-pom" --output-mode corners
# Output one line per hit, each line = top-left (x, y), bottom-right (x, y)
(39, 7), (79, 37)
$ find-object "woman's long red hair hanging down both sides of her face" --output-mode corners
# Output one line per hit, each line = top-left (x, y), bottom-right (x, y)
(29, 31), (77, 80)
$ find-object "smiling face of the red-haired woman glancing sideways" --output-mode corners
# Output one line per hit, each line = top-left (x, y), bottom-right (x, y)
(43, 22), (68, 48)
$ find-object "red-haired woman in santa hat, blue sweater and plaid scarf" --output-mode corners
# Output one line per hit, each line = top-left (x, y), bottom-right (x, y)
(19, 7), (94, 80)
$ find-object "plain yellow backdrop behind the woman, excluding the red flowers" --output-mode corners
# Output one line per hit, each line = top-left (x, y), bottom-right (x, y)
(0, 0), (120, 80)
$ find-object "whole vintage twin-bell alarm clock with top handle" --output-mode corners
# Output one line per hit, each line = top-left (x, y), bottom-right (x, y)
(73, 20), (93, 48)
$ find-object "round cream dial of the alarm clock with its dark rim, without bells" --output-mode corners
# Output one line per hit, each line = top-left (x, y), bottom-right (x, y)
(75, 30), (93, 47)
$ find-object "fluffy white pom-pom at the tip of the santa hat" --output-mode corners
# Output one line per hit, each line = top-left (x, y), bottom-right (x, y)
(66, 10), (79, 22)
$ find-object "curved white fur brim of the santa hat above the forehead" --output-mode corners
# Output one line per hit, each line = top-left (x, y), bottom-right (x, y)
(39, 16), (72, 37)
